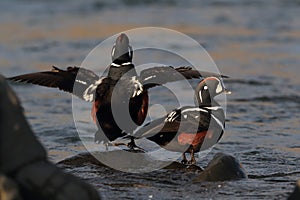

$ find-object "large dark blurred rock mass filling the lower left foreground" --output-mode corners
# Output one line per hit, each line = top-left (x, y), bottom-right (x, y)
(0, 76), (100, 200)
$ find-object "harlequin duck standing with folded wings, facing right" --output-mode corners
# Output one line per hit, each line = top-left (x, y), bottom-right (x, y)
(133, 77), (230, 164)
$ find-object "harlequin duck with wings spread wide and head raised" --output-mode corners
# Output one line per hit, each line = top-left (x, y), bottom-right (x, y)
(9, 34), (225, 148)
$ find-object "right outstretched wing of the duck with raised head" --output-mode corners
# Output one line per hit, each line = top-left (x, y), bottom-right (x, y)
(140, 66), (226, 89)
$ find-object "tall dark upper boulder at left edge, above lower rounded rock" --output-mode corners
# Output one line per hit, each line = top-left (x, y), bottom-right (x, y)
(0, 76), (46, 173)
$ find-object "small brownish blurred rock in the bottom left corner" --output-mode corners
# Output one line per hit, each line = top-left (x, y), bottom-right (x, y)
(0, 174), (22, 200)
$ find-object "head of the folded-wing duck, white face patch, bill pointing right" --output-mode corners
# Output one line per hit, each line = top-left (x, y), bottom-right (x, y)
(195, 77), (231, 106)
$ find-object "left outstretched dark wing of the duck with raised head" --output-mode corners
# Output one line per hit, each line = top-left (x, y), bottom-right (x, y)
(8, 66), (101, 101)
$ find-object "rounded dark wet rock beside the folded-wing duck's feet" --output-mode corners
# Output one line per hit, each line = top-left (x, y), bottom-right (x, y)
(194, 153), (247, 182)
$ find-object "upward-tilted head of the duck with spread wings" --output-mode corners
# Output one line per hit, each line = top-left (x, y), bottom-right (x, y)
(111, 33), (133, 65)
